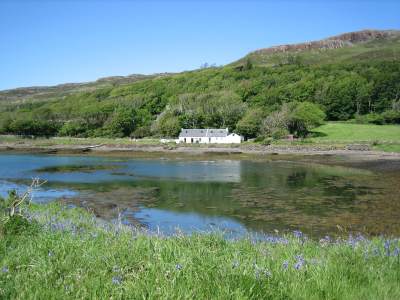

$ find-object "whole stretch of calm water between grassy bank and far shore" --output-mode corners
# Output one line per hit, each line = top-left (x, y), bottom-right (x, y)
(0, 154), (400, 236)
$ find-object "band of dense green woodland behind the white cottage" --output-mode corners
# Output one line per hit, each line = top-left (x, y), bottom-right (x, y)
(0, 60), (400, 138)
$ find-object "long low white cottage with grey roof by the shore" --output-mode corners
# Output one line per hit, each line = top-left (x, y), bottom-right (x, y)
(177, 128), (243, 144)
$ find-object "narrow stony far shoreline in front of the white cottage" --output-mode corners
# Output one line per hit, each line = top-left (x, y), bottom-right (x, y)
(0, 143), (400, 160)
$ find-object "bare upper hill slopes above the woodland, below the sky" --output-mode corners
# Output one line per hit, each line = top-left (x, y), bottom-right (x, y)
(0, 29), (400, 102)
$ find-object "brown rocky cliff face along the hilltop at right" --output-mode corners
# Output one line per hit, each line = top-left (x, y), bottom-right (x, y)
(253, 30), (400, 54)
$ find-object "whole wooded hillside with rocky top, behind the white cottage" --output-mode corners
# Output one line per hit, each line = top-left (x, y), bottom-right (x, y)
(0, 30), (400, 137)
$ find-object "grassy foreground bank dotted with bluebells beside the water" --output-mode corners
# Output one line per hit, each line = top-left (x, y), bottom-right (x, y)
(0, 204), (400, 299)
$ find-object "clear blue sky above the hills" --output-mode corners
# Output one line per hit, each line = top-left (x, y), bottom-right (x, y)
(0, 0), (400, 89)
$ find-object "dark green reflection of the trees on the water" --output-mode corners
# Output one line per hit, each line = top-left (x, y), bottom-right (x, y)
(56, 161), (396, 234)
